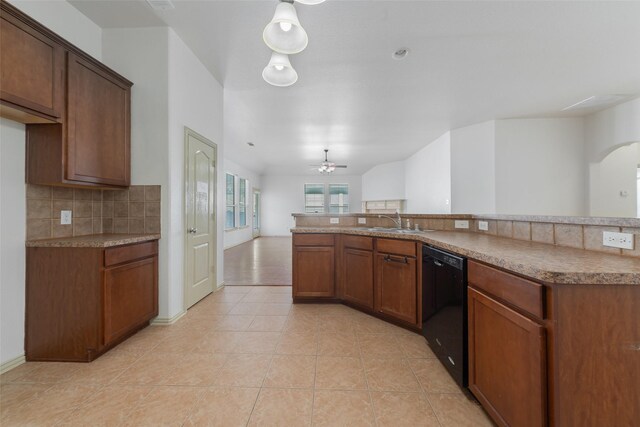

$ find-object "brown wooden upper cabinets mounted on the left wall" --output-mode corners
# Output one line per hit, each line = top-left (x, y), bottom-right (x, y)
(0, 0), (132, 188)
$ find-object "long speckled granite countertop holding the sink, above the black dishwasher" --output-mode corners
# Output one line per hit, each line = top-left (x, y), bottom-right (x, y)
(291, 227), (640, 285)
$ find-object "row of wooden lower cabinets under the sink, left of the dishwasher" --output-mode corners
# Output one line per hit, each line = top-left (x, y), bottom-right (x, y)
(293, 233), (421, 329)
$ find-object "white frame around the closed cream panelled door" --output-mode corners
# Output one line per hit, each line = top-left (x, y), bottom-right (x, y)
(182, 126), (218, 312)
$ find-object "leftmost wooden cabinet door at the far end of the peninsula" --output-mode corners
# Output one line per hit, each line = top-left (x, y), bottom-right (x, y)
(293, 246), (335, 297)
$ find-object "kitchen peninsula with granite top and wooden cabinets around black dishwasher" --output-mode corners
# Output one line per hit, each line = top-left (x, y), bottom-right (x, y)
(292, 215), (640, 426)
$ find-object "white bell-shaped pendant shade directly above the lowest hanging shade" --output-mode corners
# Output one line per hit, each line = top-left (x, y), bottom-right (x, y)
(262, 2), (309, 55)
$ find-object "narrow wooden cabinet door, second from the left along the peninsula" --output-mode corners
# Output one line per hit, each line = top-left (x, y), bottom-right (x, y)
(343, 248), (373, 310)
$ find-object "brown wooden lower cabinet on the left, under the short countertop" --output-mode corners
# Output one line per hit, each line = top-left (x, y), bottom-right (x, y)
(25, 241), (158, 362)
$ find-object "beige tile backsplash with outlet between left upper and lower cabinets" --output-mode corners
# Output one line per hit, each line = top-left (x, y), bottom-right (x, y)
(27, 184), (160, 240)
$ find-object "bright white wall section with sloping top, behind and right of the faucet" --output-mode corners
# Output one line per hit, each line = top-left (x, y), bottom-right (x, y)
(404, 132), (451, 214)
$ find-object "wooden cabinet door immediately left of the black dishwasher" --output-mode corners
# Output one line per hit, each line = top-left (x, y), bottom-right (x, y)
(376, 253), (418, 324)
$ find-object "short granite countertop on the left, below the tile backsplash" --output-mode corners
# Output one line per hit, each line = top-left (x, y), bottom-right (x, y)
(25, 234), (160, 248)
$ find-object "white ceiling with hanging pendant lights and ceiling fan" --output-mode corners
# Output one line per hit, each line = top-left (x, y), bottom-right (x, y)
(71, 0), (640, 174)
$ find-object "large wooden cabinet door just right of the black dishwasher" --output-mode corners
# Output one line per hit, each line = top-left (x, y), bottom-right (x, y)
(468, 288), (547, 427)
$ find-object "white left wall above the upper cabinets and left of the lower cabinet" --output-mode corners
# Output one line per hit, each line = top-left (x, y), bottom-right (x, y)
(0, 0), (102, 364)
